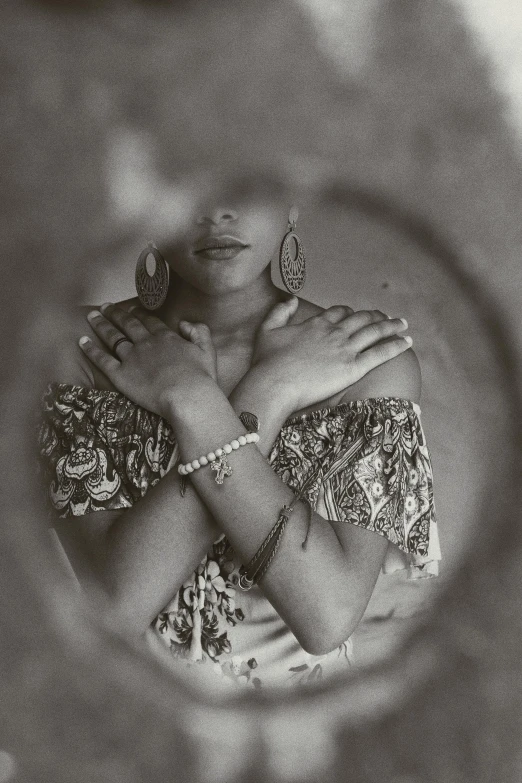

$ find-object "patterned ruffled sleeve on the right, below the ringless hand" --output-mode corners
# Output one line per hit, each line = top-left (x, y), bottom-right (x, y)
(270, 397), (441, 579)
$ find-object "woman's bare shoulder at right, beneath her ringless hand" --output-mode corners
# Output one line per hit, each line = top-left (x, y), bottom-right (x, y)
(295, 298), (422, 404)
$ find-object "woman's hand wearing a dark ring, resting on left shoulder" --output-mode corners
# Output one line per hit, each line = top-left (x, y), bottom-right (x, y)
(80, 304), (217, 417)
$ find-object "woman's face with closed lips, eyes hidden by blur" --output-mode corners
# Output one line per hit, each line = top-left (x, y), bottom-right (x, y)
(159, 170), (291, 295)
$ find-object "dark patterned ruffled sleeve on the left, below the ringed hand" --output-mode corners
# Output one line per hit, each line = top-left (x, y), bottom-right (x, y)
(37, 384), (177, 517)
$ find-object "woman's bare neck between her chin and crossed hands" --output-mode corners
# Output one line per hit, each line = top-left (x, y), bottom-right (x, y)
(160, 267), (287, 347)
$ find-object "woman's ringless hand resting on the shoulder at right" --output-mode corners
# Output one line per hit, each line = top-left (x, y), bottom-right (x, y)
(248, 297), (411, 410)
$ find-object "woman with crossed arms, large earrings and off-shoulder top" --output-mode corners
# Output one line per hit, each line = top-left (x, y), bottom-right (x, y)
(36, 175), (440, 687)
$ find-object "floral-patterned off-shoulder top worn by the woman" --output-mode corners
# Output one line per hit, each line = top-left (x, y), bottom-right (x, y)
(38, 383), (441, 687)
